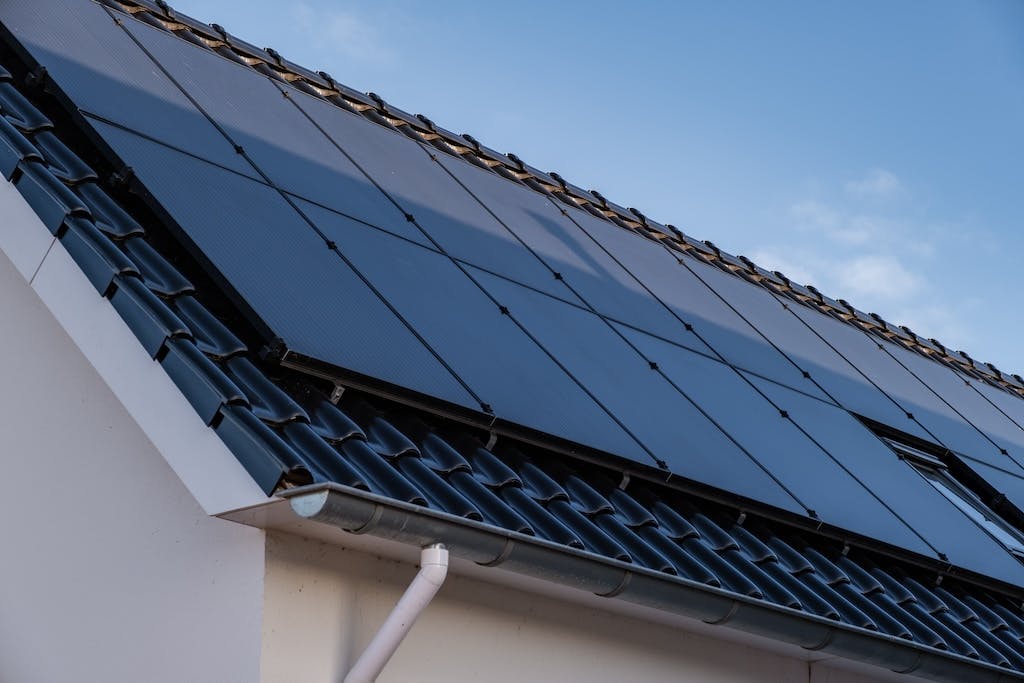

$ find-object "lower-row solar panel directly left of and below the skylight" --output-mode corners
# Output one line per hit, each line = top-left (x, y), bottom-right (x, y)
(751, 377), (1024, 584)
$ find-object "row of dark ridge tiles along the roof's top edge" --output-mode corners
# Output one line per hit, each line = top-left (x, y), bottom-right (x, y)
(99, 0), (1024, 398)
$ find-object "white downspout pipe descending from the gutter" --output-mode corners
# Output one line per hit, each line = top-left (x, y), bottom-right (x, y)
(344, 543), (447, 683)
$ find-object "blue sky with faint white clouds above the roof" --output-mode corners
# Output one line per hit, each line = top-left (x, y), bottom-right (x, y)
(171, 0), (1024, 374)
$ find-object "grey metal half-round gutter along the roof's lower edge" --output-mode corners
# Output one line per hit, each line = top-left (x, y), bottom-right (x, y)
(279, 483), (1024, 683)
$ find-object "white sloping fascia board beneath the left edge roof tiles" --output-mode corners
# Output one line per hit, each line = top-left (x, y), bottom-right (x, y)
(0, 177), (273, 515)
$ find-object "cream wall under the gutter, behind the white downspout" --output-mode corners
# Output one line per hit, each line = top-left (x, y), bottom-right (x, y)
(262, 532), (888, 683)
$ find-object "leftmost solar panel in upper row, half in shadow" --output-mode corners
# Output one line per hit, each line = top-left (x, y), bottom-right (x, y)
(2, 0), (251, 179)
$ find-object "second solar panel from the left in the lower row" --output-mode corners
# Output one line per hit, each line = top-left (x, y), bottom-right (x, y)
(292, 197), (653, 464)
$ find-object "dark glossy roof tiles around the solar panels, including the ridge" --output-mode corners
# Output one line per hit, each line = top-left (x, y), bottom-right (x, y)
(6, 3), (1024, 672)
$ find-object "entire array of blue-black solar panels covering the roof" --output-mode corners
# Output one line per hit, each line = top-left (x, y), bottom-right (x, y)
(12, 0), (1024, 585)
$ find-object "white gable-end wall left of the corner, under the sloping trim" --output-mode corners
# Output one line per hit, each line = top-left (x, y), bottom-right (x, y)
(0, 242), (264, 683)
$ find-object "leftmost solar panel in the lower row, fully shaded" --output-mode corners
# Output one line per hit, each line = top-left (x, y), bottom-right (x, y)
(93, 122), (479, 409)
